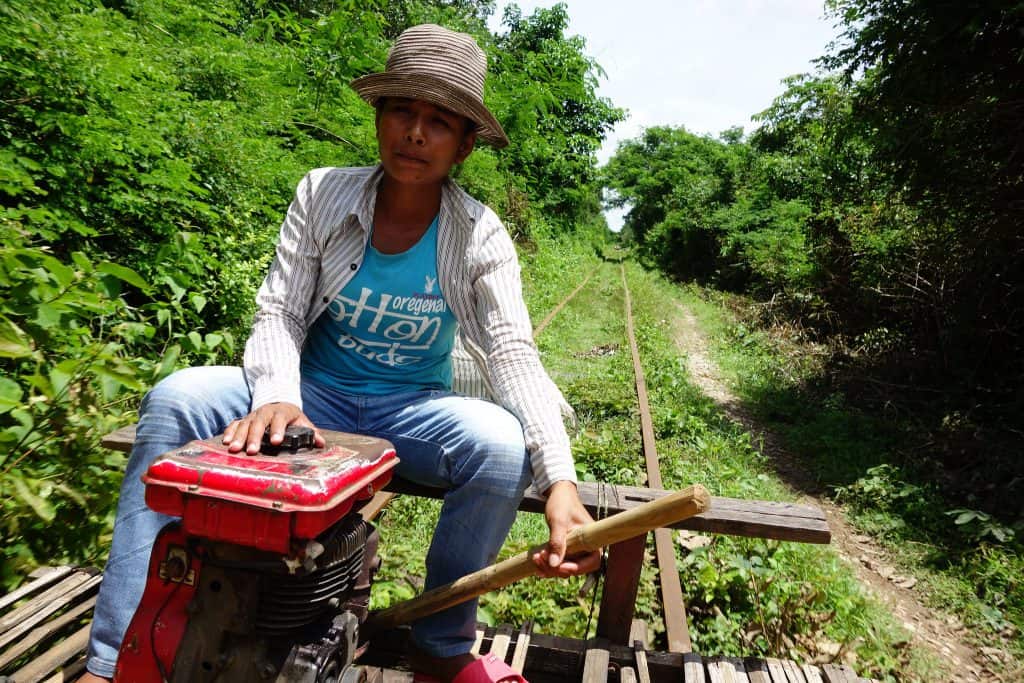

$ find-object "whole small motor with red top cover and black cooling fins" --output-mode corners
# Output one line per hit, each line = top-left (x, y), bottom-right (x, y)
(115, 428), (398, 683)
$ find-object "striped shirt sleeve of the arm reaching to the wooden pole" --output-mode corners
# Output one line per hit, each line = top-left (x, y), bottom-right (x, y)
(471, 211), (577, 494)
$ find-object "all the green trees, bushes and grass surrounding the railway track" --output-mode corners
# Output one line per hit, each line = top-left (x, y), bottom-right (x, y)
(0, 0), (1024, 680)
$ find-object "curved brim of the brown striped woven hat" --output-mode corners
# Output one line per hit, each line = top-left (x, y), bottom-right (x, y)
(350, 72), (509, 150)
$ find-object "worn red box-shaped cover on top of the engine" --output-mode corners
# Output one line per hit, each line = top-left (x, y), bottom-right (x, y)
(142, 431), (398, 553)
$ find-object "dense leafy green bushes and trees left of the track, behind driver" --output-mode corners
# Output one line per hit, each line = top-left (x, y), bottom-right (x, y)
(0, 0), (622, 585)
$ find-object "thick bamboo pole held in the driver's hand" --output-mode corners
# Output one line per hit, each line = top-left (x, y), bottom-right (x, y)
(367, 484), (711, 629)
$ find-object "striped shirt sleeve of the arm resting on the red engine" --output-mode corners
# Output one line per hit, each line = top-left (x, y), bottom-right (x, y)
(244, 173), (321, 410)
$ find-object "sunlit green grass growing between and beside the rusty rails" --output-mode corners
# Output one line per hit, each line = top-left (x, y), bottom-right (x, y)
(374, 237), (950, 680)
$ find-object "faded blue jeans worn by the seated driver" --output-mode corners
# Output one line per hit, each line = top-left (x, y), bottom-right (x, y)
(87, 367), (530, 677)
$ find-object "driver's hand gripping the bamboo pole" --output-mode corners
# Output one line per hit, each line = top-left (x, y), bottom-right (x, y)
(532, 481), (601, 579)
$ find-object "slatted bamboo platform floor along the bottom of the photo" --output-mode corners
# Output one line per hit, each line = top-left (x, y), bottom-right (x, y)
(0, 566), (867, 683)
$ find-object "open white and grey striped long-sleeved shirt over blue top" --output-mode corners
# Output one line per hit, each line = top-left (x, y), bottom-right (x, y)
(245, 166), (575, 493)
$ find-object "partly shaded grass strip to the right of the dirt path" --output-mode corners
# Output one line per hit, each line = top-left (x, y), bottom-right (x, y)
(684, 288), (1024, 678)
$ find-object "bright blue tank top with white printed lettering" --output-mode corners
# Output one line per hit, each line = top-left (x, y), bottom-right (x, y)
(302, 217), (456, 395)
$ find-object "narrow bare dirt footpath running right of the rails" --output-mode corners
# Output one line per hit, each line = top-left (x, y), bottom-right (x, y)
(674, 305), (1008, 681)
